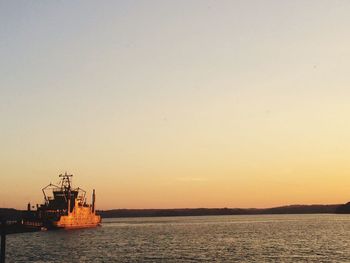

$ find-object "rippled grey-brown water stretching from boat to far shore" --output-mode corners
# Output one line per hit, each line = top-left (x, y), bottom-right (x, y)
(7, 215), (350, 262)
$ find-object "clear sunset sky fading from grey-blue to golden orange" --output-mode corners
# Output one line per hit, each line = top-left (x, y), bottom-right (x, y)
(0, 0), (350, 209)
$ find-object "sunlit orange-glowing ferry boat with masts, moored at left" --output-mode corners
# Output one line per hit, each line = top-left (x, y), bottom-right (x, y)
(23, 173), (101, 229)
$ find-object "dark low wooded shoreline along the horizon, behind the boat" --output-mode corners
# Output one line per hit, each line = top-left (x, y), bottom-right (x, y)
(0, 202), (350, 223)
